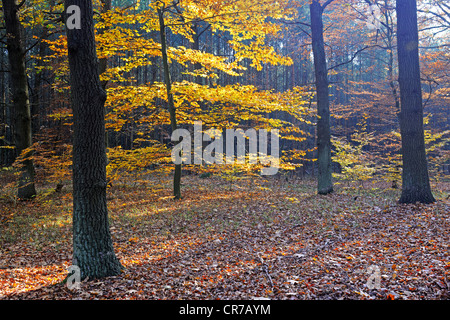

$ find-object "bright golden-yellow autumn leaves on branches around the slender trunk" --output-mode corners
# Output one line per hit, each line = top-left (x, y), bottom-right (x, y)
(38, 0), (311, 181)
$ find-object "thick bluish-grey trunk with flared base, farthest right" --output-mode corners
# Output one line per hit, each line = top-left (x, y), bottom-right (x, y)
(396, 0), (435, 203)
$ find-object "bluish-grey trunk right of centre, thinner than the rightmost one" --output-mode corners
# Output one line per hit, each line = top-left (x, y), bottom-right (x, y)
(310, 0), (333, 194)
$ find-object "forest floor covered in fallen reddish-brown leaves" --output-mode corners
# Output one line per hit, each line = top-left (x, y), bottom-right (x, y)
(0, 172), (450, 300)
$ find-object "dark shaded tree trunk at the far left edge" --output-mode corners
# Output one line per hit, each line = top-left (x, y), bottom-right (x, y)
(2, 0), (36, 199)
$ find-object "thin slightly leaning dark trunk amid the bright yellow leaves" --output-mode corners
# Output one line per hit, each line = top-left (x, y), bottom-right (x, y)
(158, 8), (181, 199)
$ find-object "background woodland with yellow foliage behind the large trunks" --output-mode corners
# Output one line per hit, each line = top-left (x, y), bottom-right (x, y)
(0, 0), (450, 202)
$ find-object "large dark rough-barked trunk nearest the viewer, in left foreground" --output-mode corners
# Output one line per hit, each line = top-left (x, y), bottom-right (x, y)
(65, 0), (122, 279)
